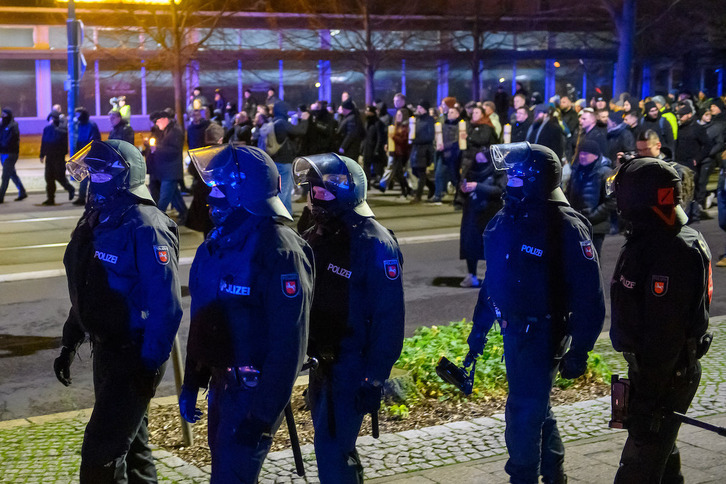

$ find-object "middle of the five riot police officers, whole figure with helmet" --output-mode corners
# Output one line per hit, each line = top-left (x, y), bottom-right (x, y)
(293, 153), (404, 484)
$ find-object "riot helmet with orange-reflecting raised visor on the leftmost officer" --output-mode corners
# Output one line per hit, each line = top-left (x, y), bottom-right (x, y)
(66, 139), (153, 203)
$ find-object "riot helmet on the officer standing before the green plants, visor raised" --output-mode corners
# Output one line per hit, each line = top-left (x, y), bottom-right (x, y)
(490, 141), (568, 203)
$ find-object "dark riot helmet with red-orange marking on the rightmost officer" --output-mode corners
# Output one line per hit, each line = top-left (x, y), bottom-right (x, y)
(608, 158), (688, 227)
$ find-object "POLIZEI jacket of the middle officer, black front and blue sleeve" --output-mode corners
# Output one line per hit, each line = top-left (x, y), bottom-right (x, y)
(303, 212), (405, 381)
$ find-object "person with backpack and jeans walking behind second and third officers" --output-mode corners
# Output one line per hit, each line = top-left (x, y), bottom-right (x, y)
(257, 101), (310, 214)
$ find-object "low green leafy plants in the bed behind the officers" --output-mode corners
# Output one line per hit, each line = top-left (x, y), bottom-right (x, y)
(396, 320), (610, 403)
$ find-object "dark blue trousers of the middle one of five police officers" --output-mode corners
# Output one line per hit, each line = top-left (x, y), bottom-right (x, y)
(308, 361), (364, 484)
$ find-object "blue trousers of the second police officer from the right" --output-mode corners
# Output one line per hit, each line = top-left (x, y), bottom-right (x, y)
(504, 320), (565, 484)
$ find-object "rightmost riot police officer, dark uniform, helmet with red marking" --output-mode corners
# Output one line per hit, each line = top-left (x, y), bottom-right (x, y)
(610, 158), (713, 483)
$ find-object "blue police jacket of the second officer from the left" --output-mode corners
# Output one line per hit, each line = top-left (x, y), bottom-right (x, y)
(185, 214), (314, 423)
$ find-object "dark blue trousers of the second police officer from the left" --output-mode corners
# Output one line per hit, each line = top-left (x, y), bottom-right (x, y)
(208, 372), (282, 484)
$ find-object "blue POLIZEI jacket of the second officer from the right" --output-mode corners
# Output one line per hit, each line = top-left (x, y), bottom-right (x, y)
(474, 195), (605, 354)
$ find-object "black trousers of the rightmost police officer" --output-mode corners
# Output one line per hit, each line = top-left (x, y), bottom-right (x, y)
(615, 362), (701, 484)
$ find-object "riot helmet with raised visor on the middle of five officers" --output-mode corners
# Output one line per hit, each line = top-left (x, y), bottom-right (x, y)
(292, 153), (375, 217)
